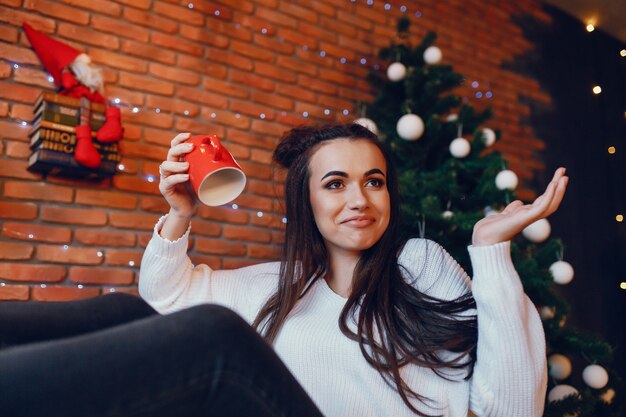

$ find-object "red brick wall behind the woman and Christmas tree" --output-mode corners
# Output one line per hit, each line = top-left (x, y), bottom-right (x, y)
(0, 0), (549, 300)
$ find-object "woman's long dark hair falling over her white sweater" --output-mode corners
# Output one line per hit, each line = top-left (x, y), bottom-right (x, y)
(252, 124), (477, 416)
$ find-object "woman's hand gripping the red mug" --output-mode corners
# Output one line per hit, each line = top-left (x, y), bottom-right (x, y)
(159, 133), (198, 219)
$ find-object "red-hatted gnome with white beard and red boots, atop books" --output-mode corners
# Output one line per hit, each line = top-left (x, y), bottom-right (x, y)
(22, 23), (124, 169)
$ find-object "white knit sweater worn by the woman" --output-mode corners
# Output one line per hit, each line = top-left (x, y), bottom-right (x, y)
(139, 214), (547, 417)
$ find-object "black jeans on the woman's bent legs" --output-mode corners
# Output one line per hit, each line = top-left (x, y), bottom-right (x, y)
(0, 294), (322, 417)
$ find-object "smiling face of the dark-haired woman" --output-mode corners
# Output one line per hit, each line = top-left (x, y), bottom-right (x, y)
(309, 138), (390, 253)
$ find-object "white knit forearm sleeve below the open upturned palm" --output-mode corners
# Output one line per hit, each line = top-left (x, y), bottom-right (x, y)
(468, 242), (547, 417)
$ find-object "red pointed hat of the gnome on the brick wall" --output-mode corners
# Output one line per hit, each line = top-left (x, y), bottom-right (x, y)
(22, 23), (82, 86)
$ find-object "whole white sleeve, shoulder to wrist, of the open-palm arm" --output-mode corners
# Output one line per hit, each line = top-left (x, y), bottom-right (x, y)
(398, 239), (547, 417)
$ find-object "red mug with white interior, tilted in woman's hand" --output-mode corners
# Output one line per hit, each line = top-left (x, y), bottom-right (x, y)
(184, 135), (246, 206)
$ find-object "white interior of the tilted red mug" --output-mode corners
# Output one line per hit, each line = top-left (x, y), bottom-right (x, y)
(198, 167), (246, 206)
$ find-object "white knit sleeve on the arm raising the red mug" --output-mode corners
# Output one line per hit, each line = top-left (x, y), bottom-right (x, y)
(139, 216), (279, 316)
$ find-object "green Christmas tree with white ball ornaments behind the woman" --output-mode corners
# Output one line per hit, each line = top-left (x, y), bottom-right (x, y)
(357, 18), (624, 417)
